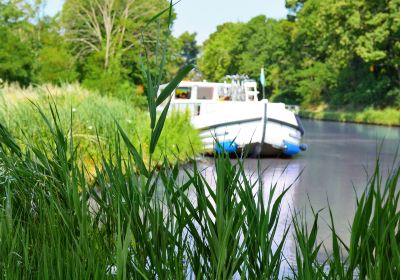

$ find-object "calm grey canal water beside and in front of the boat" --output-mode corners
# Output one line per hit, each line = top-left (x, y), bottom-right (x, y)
(195, 120), (400, 260)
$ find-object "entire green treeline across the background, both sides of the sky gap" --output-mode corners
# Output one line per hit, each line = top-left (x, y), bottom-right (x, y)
(0, 0), (400, 110)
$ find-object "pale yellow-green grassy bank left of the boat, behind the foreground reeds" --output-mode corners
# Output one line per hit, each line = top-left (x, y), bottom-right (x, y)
(0, 84), (202, 166)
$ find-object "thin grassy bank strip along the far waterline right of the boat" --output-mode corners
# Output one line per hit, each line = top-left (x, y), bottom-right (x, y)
(299, 108), (400, 126)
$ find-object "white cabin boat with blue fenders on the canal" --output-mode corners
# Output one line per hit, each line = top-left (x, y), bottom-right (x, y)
(160, 76), (307, 156)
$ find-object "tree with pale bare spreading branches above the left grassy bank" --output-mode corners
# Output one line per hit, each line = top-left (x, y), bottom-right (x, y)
(62, 0), (173, 94)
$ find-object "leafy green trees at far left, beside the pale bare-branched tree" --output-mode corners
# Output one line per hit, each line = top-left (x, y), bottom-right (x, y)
(0, 1), (78, 86)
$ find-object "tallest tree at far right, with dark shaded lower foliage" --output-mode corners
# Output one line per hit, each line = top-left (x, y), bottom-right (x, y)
(292, 0), (400, 105)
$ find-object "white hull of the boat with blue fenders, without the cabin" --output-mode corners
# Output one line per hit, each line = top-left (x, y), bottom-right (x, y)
(170, 101), (303, 156)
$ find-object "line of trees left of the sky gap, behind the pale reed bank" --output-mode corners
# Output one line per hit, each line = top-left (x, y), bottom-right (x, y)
(0, 0), (198, 96)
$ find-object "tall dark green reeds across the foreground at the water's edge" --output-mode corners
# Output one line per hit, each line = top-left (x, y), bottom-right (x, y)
(0, 106), (400, 279)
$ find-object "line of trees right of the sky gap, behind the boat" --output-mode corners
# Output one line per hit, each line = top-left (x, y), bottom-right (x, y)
(199, 0), (400, 110)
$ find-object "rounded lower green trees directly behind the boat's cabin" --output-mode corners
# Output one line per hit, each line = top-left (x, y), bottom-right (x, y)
(199, 16), (297, 101)
